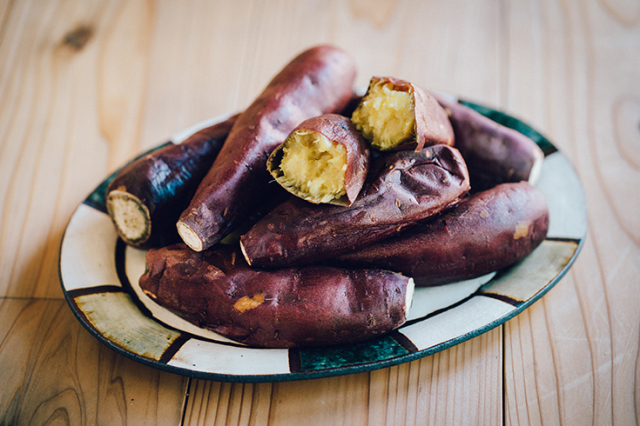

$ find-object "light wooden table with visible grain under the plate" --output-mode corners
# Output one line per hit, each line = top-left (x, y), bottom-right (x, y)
(0, 0), (640, 425)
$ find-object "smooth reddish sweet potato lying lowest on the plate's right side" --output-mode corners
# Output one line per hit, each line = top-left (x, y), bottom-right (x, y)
(331, 182), (549, 286)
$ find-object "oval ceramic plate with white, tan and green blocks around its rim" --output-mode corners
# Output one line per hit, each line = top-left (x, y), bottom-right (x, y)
(60, 100), (587, 382)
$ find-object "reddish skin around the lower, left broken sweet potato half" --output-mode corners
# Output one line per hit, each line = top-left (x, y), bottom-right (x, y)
(267, 114), (369, 205)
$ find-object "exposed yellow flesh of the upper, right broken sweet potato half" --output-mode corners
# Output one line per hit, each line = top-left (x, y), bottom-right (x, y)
(351, 83), (415, 151)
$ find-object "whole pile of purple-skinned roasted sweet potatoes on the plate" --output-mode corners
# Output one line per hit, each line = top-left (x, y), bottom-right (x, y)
(108, 46), (549, 347)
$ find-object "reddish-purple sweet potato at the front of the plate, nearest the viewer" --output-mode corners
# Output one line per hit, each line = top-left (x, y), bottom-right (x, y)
(140, 244), (413, 348)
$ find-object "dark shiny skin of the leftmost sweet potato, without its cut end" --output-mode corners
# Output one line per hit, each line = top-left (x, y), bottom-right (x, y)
(107, 114), (238, 248)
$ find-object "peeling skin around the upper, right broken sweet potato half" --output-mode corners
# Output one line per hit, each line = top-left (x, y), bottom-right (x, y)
(356, 77), (455, 151)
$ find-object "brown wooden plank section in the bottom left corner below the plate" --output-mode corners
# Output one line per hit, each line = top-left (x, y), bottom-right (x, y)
(0, 299), (188, 425)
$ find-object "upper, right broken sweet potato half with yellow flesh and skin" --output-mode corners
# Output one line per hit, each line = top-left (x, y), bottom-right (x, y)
(351, 77), (454, 151)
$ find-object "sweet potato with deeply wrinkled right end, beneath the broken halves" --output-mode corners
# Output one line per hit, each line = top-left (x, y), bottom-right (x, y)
(240, 145), (469, 267)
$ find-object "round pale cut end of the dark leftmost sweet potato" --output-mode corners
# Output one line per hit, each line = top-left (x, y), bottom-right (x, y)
(107, 190), (151, 244)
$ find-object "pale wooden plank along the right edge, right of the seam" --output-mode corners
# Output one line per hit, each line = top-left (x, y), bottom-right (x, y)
(505, 1), (640, 424)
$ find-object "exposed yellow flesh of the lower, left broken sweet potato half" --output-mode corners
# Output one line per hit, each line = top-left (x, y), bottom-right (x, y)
(278, 130), (347, 203)
